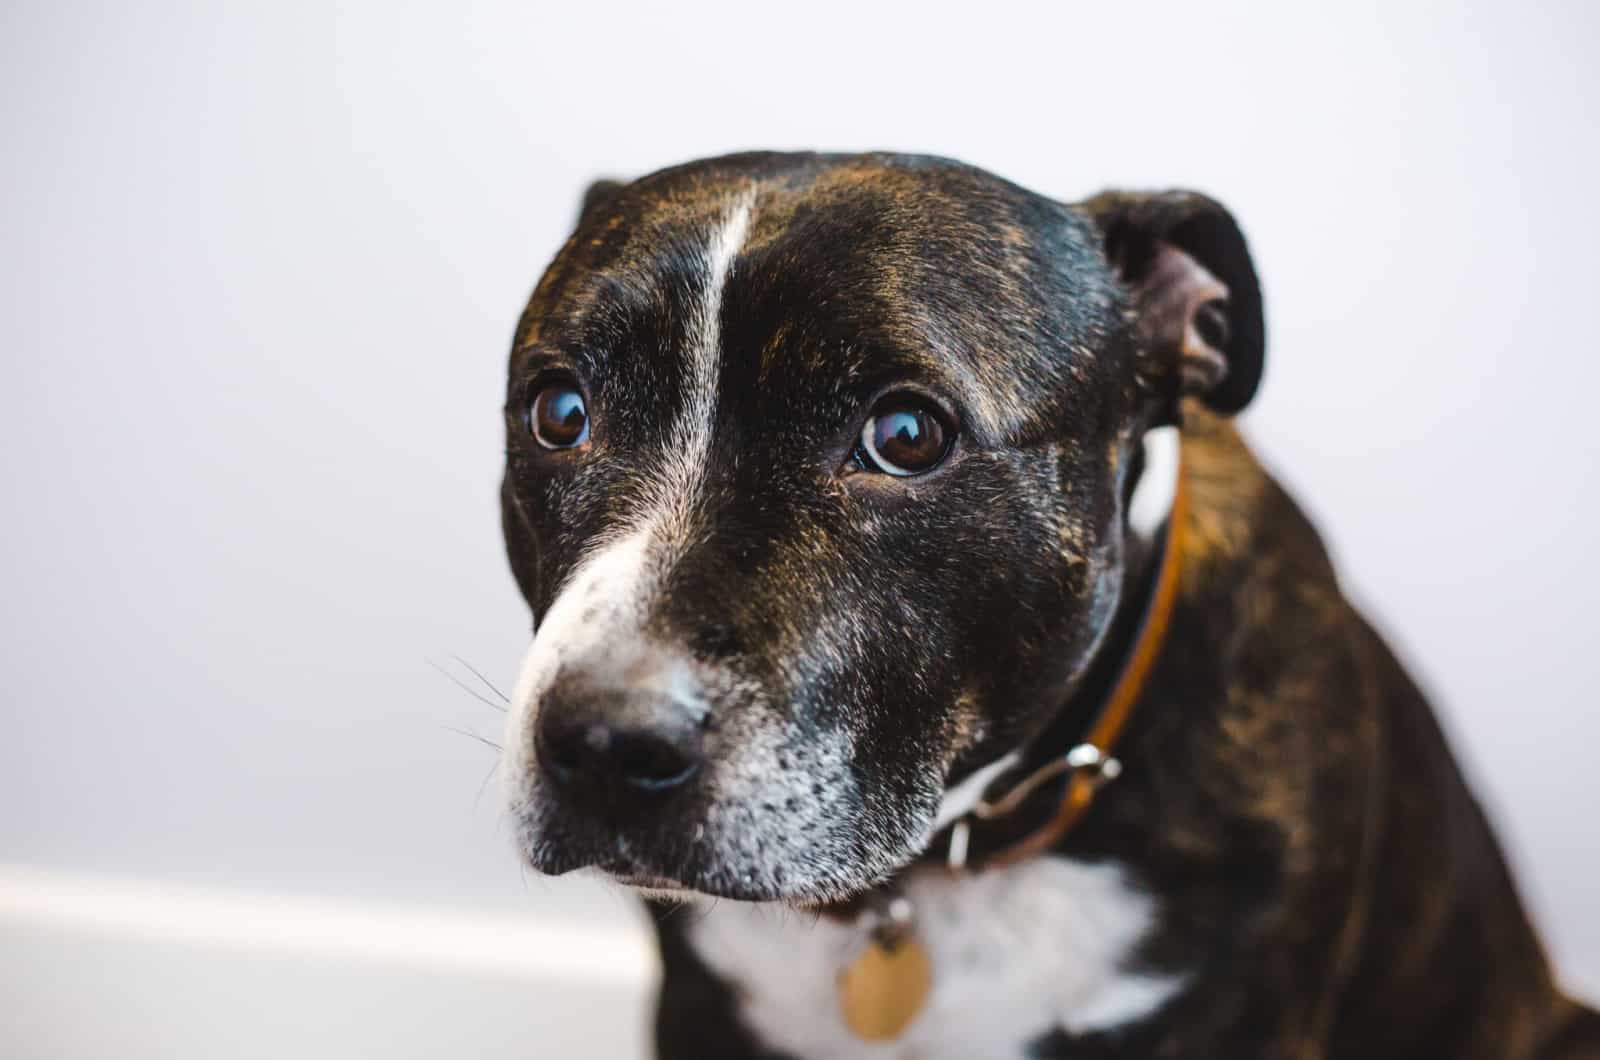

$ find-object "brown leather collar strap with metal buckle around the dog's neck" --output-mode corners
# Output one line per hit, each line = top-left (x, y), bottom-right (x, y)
(949, 445), (1189, 869)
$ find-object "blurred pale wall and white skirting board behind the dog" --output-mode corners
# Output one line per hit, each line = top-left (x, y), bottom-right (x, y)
(0, 0), (1600, 1060)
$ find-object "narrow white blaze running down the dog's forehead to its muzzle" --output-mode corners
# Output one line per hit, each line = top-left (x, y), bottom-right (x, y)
(506, 191), (755, 785)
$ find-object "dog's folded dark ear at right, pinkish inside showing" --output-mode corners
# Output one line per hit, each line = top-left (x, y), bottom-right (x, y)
(1082, 192), (1266, 413)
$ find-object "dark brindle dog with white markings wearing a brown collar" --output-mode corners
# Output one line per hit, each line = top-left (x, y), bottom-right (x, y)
(502, 154), (1600, 1060)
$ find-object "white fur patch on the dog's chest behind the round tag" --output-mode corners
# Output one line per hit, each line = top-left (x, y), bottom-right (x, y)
(682, 858), (1184, 1060)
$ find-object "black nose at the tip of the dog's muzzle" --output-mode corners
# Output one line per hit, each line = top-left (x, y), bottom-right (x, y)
(534, 689), (704, 793)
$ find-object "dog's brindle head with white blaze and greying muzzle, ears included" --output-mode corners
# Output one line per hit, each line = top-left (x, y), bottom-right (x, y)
(502, 155), (1261, 901)
